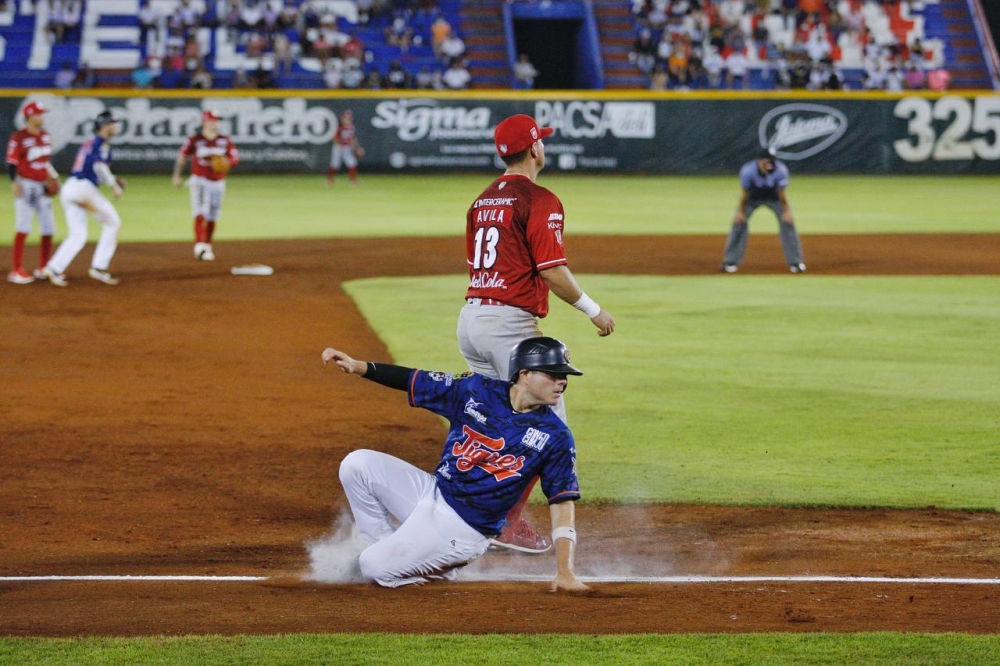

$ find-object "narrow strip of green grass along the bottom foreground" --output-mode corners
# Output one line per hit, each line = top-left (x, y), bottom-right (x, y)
(0, 633), (1000, 666)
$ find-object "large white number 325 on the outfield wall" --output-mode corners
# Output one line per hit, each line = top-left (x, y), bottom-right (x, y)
(892, 96), (1000, 162)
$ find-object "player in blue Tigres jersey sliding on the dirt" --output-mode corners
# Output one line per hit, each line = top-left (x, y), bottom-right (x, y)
(322, 337), (588, 592)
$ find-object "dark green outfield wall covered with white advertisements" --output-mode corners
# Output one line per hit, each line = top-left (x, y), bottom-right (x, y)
(0, 94), (1000, 176)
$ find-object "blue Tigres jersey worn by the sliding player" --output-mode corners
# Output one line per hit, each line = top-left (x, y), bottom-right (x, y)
(409, 370), (580, 536)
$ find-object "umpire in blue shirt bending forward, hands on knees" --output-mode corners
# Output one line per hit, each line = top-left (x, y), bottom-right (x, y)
(720, 151), (806, 273)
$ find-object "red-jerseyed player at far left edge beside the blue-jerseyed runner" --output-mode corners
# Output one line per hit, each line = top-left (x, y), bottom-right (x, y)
(7, 102), (59, 284)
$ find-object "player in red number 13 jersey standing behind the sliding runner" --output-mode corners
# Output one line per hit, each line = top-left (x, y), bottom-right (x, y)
(458, 114), (615, 553)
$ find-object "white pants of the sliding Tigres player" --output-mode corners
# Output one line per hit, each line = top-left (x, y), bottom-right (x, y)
(340, 449), (490, 587)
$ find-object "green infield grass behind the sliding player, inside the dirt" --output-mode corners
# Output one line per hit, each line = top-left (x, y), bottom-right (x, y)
(346, 275), (1000, 510)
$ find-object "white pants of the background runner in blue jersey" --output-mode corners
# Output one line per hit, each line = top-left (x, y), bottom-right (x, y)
(48, 178), (122, 273)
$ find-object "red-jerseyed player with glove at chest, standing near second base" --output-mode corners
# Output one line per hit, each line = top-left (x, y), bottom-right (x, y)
(173, 110), (239, 261)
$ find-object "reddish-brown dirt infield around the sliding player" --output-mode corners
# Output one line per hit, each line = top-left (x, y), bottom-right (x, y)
(0, 235), (1000, 636)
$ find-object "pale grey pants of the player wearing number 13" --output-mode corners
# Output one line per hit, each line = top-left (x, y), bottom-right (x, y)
(457, 298), (569, 423)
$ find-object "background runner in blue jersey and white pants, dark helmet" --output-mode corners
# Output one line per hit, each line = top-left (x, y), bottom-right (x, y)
(42, 111), (125, 287)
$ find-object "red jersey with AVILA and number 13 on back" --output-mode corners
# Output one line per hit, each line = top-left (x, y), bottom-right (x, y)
(465, 176), (567, 317)
